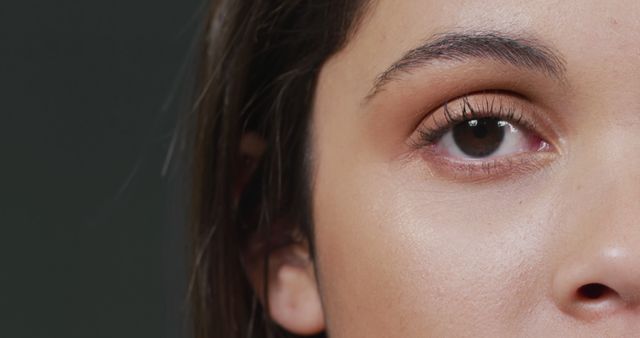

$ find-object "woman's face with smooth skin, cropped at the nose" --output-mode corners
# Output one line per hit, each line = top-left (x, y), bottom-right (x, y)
(313, 0), (640, 337)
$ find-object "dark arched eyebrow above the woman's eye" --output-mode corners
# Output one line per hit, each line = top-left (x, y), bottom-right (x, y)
(365, 31), (566, 102)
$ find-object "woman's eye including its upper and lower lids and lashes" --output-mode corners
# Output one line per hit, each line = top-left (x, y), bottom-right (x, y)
(412, 93), (557, 179)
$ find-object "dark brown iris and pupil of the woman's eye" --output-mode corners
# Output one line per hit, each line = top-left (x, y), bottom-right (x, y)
(453, 118), (505, 158)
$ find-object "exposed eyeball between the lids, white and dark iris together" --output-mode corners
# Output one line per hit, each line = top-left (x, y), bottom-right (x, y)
(436, 117), (542, 160)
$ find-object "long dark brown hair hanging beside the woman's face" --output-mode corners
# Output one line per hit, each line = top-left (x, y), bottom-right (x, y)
(189, 0), (364, 338)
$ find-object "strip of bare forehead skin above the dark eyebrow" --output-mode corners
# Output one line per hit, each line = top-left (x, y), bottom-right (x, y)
(360, 0), (640, 51)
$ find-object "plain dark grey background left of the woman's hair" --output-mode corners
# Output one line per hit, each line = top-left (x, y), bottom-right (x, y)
(0, 0), (204, 338)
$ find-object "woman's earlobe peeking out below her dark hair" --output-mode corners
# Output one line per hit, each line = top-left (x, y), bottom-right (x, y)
(247, 244), (325, 335)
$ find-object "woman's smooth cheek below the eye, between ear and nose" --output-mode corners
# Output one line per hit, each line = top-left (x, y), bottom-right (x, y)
(314, 153), (552, 337)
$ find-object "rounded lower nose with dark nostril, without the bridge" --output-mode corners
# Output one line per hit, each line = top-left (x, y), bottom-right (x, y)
(553, 243), (640, 320)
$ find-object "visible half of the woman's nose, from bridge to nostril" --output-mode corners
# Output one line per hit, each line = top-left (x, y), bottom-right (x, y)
(550, 128), (640, 323)
